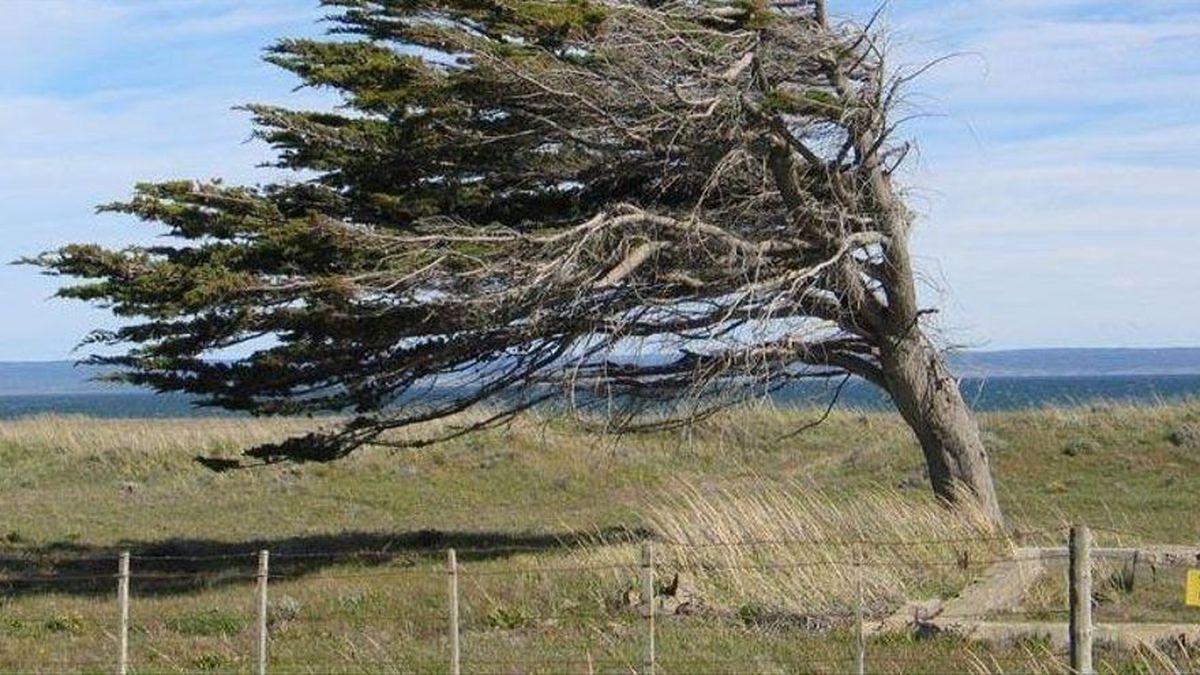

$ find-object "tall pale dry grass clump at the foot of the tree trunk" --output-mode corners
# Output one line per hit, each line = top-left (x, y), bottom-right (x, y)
(580, 479), (1013, 623)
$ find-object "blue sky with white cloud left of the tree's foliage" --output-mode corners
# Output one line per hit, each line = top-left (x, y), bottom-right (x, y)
(0, 0), (330, 359)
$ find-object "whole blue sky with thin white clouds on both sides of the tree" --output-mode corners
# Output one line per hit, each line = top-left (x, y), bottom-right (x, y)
(0, 0), (1200, 360)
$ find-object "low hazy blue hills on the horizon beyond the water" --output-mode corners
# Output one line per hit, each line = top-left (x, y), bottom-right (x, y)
(0, 347), (1200, 396)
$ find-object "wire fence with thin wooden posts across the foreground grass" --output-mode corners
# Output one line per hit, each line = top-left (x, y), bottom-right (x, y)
(0, 530), (1195, 675)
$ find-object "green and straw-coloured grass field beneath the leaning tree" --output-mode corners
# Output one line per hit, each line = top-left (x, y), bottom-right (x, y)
(0, 404), (1200, 673)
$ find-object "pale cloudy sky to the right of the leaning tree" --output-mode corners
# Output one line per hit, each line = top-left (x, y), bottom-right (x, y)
(873, 0), (1200, 347)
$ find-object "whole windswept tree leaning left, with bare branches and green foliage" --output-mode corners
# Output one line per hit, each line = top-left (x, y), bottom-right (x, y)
(36, 0), (1000, 521)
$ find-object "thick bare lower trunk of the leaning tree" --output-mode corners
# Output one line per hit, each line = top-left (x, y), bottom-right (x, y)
(882, 328), (1003, 525)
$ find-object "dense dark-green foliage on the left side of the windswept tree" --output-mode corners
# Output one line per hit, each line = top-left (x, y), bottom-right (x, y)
(25, 0), (739, 460)
